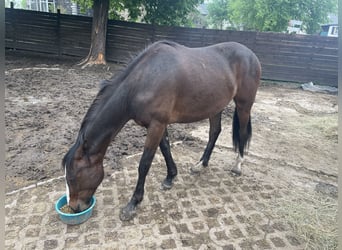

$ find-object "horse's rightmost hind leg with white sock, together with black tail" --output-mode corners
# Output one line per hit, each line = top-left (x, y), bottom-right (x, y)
(231, 104), (252, 175)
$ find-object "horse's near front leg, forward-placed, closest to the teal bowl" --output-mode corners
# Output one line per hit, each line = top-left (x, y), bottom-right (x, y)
(120, 122), (166, 221)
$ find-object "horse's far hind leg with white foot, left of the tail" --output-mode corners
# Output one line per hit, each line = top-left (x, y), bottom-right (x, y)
(191, 112), (222, 173)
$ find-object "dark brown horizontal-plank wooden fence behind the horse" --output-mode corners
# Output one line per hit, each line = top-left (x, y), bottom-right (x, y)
(5, 9), (338, 87)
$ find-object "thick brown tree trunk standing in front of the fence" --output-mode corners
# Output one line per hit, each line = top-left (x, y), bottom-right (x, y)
(79, 0), (109, 68)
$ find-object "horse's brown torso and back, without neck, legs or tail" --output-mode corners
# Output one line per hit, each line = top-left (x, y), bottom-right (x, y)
(130, 41), (257, 125)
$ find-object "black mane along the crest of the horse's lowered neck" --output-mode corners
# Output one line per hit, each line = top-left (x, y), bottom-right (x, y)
(62, 40), (178, 168)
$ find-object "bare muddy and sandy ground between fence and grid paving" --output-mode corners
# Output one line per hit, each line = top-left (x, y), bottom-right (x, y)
(5, 52), (338, 248)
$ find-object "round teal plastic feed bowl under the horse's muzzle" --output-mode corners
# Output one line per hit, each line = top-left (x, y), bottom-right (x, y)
(55, 195), (96, 225)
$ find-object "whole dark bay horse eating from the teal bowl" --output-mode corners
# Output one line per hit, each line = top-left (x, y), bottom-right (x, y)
(62, 41), (261, 220)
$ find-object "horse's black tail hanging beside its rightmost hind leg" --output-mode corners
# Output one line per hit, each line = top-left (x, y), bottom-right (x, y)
(233, 108), (252, 157)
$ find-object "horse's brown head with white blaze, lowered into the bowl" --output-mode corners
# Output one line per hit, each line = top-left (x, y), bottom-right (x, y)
(62, 145), (104, 212)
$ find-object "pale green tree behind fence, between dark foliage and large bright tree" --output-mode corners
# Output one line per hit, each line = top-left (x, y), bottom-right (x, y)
(207, 0), (228, 29)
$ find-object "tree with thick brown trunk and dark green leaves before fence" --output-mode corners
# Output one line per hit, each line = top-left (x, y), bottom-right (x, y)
(74, 0), (203, 67)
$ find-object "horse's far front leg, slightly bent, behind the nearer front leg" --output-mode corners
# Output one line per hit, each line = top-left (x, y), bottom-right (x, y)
(159, 129), (177, 189)
